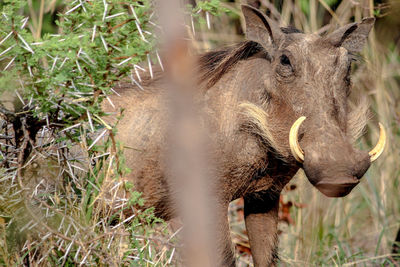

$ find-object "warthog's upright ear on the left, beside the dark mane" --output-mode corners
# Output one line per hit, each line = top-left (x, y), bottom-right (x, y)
(242, 5), (285, 55)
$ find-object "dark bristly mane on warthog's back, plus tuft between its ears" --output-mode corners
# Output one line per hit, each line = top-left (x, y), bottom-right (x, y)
(199, 26), (302, 89)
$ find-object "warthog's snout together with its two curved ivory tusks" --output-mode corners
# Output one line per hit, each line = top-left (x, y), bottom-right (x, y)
(289, 117), (386, 197)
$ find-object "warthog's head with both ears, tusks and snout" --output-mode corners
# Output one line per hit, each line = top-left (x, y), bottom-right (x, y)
(242, 6), (385, 197)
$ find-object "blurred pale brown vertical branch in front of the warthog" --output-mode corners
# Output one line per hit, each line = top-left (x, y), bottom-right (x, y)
(158, 0), (220, 267)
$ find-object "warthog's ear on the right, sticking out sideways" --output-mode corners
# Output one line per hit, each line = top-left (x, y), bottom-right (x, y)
(326, 17), (375, 53)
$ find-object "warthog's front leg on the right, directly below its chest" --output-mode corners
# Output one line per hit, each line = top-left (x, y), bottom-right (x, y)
(244, 191), (279, 267)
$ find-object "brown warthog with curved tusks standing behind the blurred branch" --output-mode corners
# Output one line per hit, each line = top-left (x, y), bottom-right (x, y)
(103, 6), (385, 266)
